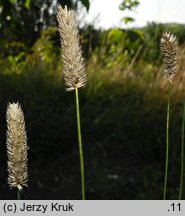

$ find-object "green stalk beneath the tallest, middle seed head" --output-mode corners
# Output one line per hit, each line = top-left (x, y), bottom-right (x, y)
(75, 88), (85, 200)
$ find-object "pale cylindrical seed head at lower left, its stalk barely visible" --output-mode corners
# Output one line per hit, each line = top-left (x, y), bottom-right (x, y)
(6, 103), (28, 190)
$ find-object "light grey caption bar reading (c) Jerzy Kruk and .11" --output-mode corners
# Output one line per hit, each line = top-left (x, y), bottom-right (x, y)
(0, 200), (185, 216)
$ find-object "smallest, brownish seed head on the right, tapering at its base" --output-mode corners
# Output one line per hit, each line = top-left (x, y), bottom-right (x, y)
(160, 32), (178, 83)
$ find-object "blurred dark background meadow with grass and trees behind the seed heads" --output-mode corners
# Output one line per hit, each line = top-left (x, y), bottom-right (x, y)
(0, 0), (185, 199)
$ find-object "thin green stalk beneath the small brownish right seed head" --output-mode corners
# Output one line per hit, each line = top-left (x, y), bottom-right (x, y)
(163, 81), (170, 200)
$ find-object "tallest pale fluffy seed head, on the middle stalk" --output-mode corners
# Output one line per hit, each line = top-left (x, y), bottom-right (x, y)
(57, 4), (87, 91)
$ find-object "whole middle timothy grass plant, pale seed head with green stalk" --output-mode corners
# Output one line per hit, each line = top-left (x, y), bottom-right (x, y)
(57, 4), (87, 200)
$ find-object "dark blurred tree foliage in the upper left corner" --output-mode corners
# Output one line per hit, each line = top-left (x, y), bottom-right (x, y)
(0, 0), (89, 47)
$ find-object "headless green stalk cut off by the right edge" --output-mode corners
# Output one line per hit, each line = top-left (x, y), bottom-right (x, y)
(179, 101), (185, 200)
